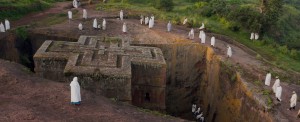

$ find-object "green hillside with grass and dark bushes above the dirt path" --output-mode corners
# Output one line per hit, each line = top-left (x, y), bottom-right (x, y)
(98, 0), (300, 71)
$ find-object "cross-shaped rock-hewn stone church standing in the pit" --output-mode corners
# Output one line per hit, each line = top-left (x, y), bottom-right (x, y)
(34, 36), (166, 110)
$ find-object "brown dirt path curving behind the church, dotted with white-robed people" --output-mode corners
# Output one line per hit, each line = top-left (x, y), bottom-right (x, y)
(2, 0), (300, 121)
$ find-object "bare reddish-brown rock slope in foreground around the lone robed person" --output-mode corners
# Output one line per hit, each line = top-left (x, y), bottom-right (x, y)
(0, 59), (185, 122)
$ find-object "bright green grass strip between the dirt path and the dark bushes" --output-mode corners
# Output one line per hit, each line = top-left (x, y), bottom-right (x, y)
(99, 0), (300, 72)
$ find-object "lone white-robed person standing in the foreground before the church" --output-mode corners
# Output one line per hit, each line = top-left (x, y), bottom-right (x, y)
(70, 77), (81, 105)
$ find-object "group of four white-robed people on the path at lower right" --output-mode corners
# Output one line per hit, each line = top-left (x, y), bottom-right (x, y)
(265, 72), (300, 112)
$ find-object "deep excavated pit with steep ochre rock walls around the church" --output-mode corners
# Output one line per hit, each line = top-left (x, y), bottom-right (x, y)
(0, 34), (272, 122)
